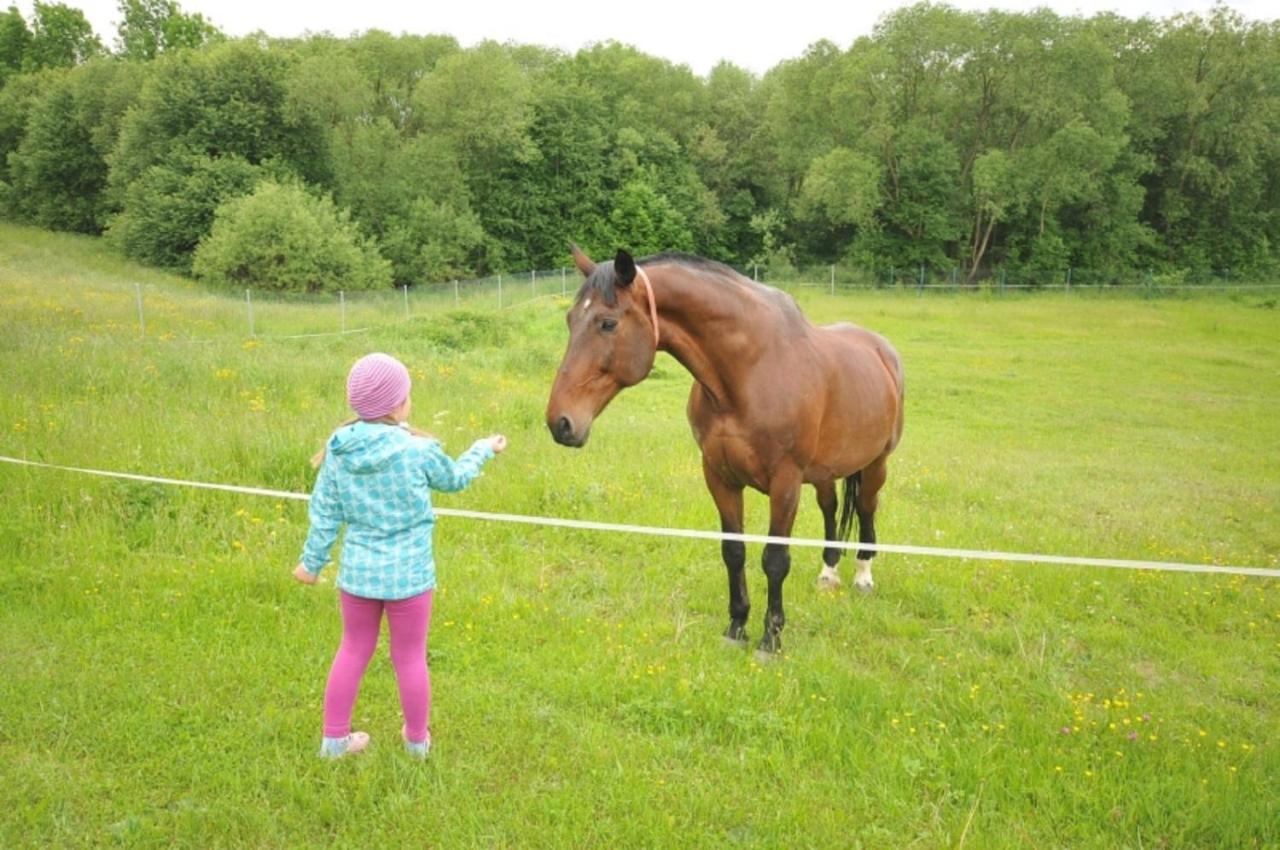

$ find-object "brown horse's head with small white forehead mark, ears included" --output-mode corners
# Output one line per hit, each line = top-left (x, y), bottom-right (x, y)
(547, 245), (657, 448)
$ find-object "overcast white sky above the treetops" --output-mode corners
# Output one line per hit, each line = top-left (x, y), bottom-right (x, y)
(15, 0), (1280, 74)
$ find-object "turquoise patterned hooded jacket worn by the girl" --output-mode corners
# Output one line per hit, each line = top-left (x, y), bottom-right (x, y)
(302, 422), (493, 599)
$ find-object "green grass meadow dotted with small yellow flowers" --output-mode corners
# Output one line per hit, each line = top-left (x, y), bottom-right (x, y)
(0, 225), (1280, 849)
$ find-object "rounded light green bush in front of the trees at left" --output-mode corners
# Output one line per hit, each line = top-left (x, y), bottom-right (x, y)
(192, 180), (392, 292)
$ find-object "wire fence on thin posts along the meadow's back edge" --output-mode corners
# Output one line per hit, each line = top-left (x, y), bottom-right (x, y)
(5, 265), (1280, 342)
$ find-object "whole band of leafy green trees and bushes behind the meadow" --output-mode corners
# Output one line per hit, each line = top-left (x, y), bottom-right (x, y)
(0, 0), (1280, 289)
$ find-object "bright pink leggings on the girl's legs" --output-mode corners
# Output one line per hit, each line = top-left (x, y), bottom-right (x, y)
(324, 590), (431, 742)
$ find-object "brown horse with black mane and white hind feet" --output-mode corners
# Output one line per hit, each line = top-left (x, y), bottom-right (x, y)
(547, 246), (902, 653)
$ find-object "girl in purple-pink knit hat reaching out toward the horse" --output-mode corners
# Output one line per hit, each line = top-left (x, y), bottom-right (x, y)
(293, 353), (507, 758)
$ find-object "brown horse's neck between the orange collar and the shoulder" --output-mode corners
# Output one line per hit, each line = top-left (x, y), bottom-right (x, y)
(649, 265), (776, 407)
